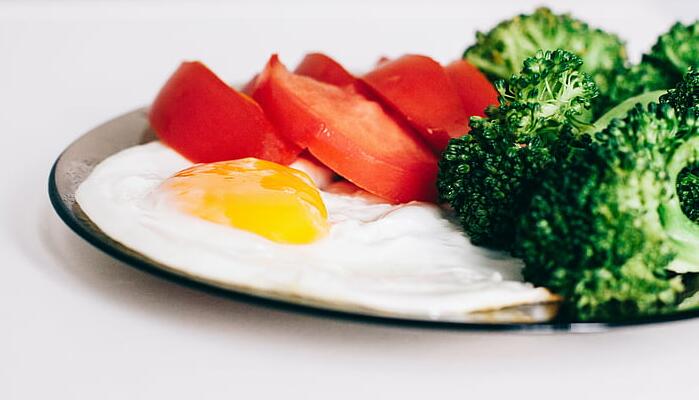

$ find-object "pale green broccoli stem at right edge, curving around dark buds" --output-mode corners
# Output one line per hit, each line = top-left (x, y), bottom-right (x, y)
(660, 135), (699, 273)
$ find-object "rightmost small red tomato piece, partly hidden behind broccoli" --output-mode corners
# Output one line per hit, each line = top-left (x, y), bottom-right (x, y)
(445, 60), (498, 117)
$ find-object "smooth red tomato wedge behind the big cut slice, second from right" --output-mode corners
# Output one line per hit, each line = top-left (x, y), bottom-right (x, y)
(362, 55), (469, 152)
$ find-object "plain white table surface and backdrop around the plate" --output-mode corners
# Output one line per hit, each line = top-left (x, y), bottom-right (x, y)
(0, 0), (699, 400)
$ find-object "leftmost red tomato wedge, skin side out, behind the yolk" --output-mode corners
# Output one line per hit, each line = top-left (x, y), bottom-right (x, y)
(148, 62), (301, 164)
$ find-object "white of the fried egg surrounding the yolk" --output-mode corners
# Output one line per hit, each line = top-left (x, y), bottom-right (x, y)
(76, 141), (554, 319)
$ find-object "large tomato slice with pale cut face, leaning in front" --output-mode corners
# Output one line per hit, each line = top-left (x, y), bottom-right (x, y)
(253, 55), (437, 203)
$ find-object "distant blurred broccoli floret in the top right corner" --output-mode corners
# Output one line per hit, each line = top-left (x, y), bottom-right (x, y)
(606, 21), (699, 105)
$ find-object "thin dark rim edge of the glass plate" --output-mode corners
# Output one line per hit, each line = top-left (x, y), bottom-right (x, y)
(48, 107), (699, 333)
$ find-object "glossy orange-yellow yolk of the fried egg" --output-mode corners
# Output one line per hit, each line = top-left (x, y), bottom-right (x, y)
(161, 158), (329, 244)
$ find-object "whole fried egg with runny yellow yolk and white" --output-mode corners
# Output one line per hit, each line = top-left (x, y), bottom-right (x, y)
(76, 141), (556, 320)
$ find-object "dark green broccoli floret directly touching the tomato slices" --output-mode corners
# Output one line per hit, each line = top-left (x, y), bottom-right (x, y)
(437, 50), (598, 249)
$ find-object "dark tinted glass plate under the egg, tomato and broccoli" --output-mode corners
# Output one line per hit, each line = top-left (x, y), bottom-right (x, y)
(49, 109), (699, 332)
